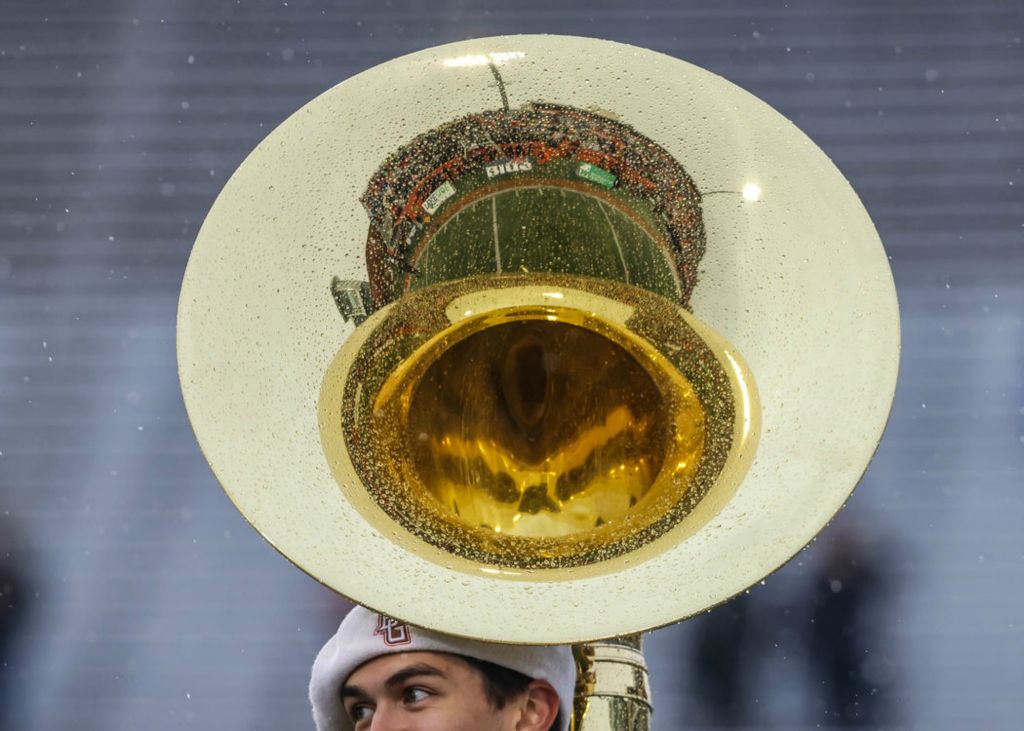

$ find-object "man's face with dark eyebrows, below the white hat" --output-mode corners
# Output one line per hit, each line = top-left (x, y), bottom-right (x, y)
(341, 652), (557, 731)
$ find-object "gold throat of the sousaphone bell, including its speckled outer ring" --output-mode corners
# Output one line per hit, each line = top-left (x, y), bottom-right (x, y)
(321, 274), (751, 570)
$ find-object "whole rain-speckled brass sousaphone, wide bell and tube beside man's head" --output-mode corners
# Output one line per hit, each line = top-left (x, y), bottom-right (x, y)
(178, 36), (899, 729)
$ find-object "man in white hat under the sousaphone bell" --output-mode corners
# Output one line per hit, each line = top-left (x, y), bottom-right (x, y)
(309, 607), (575, 731)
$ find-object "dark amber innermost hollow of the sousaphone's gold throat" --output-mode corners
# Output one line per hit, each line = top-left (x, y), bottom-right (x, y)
(391, 315), (705, 536)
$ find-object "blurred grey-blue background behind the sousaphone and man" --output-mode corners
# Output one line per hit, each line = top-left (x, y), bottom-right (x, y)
(0, 0), (1024, 731)
